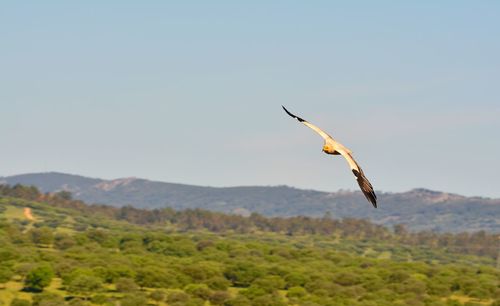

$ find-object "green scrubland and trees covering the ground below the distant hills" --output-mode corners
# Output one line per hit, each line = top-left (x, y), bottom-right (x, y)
(0, 186), (500, 306)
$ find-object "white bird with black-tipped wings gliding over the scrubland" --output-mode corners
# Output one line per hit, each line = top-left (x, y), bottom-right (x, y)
(281, 105), (377, 208)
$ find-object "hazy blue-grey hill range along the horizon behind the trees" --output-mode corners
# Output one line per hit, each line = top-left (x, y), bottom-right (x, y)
(0, 172), (500, 232)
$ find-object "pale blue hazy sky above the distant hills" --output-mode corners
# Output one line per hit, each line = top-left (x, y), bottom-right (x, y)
(0, 0), (500, 197)
